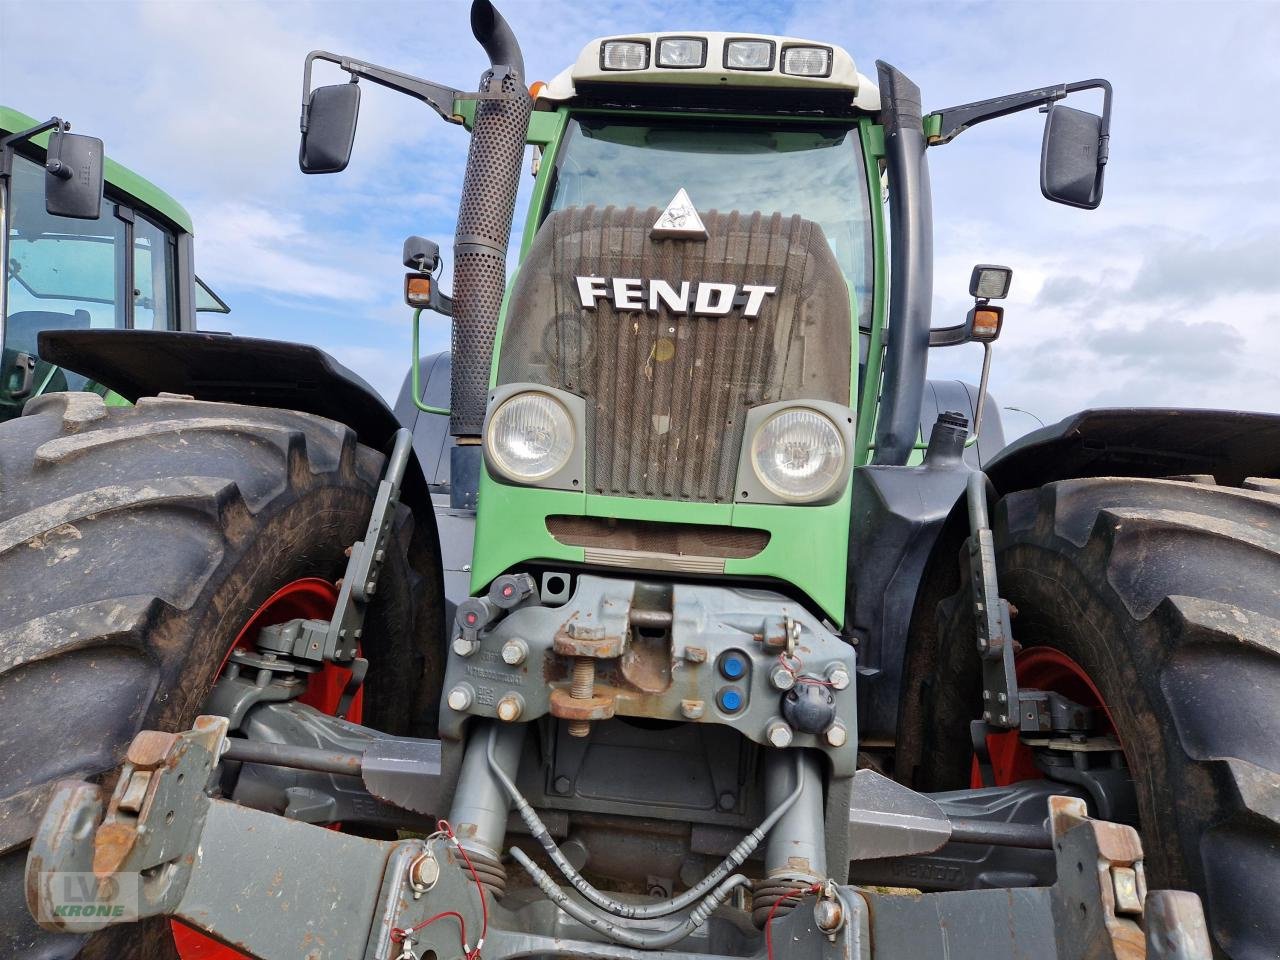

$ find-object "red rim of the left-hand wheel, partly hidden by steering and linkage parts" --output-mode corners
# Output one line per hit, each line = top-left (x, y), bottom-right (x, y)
(169, 577), (365, 960)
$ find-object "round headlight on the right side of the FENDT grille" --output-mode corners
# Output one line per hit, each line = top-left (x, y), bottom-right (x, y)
(751, 407), (845, 500)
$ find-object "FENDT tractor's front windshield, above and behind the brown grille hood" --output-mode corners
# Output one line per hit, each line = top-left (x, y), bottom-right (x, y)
(547, 115), (872, 328)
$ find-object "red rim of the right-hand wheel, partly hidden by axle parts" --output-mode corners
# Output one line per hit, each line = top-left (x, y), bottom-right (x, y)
(969, 646), (1116, 787)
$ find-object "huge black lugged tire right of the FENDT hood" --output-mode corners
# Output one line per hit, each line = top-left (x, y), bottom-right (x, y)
(899, 477), (1280, 960)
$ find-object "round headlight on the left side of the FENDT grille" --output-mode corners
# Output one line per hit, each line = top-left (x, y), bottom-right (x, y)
(485, 393), (573, 484)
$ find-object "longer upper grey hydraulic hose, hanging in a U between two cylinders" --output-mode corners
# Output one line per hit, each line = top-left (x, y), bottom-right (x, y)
(488, 731), (804, 920)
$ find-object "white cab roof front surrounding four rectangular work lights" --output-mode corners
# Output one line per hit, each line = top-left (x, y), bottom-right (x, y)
(538, 31), (879, 110)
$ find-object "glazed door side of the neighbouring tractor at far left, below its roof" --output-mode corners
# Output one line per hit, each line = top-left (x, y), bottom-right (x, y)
(0, 155), (178, 421)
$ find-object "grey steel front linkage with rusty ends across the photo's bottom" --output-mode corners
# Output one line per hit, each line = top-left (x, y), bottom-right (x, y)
(27, 717), (1210, 960)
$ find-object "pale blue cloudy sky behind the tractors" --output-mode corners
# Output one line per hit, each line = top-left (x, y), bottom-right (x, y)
(0, 0), (1280, 436)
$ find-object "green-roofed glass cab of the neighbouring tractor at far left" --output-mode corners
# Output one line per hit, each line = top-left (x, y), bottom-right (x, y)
(0, 108), (227, 420)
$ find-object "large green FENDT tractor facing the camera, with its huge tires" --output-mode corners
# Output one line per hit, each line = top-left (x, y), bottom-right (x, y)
(0, 0), (1280, 960)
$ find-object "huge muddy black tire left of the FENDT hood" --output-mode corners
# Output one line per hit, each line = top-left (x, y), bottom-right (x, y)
(0, 393), (443, 960)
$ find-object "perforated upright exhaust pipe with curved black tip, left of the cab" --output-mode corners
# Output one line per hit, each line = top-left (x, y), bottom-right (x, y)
(449, 0), (532, 438)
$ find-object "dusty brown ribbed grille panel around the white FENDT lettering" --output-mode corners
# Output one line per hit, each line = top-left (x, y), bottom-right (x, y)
(498, 207), (850, 502)
